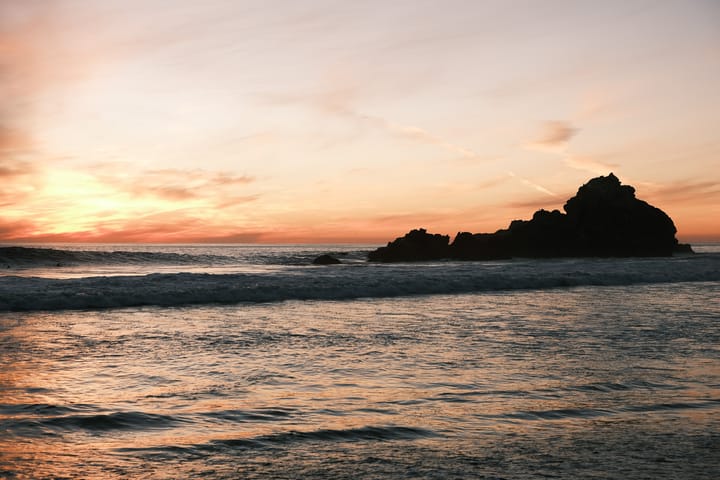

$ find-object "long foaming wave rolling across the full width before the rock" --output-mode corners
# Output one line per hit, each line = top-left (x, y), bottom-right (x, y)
(0, 254), (720, 311)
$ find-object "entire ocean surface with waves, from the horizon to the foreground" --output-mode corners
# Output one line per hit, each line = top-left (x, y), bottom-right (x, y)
(0, 244), (720, 479)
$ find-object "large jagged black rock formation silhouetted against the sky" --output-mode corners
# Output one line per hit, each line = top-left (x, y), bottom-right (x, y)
(368, 173), (692, 262)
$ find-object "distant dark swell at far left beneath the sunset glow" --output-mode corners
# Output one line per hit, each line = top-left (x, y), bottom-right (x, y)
(0, 247), (229, 268)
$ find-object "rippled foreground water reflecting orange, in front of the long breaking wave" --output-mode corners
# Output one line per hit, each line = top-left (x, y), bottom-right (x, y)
(0, 282), (720, 480)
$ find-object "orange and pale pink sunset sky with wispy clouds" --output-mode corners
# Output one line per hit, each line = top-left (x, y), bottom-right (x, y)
(0, 0), (720, 243)
